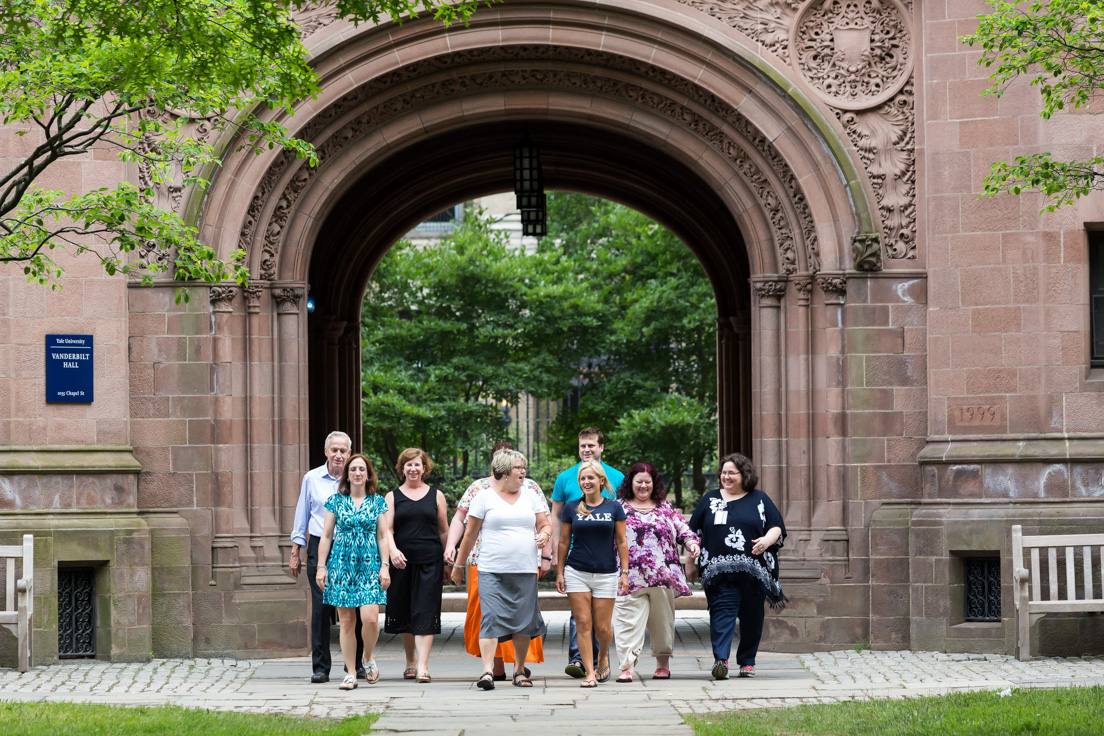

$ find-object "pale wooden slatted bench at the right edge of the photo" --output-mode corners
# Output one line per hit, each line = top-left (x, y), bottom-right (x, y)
(1012, 524), (1104, 661)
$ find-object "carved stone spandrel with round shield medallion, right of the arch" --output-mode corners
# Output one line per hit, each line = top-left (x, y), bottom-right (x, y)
(679, 0), (916, 263)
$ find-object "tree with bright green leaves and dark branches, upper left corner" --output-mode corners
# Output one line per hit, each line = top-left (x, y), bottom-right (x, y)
(0, 0), (478, 300)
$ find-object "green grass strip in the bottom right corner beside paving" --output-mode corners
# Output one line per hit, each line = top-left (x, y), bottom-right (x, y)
(687, 686), (1104, 736)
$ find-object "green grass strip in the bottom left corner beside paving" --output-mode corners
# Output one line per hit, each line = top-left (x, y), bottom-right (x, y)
(0, 702), (380, 736)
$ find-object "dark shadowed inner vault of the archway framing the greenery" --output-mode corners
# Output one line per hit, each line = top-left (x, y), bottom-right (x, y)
(308, 120), (751, 478)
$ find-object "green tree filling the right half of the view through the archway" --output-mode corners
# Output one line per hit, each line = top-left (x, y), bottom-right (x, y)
(542, 192), (716, 504)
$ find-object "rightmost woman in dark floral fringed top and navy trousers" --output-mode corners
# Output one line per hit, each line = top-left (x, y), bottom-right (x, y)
(690, 452), (786, 680)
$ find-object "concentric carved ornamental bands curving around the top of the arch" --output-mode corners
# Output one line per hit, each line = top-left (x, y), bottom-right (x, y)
(238, 45), (820, 279)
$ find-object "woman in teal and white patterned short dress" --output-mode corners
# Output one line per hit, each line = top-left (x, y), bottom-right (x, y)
(318, 455), (391, 690)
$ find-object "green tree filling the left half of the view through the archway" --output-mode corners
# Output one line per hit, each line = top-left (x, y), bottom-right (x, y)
(361, 213), (598, 485)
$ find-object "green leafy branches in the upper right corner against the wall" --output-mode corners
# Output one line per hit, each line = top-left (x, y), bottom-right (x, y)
(963, 0), (1104, 212)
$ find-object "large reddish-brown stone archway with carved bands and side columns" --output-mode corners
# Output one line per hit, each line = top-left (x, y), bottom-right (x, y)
(163, 0), (907, 653)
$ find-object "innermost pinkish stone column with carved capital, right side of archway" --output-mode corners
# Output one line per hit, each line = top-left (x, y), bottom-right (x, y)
(752, 276), (788, 513)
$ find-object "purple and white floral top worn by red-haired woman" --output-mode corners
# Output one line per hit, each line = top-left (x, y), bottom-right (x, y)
(620, 499), (699, 597)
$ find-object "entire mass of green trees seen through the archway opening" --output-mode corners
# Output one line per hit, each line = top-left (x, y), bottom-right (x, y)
(363, 192), (716, 503)
